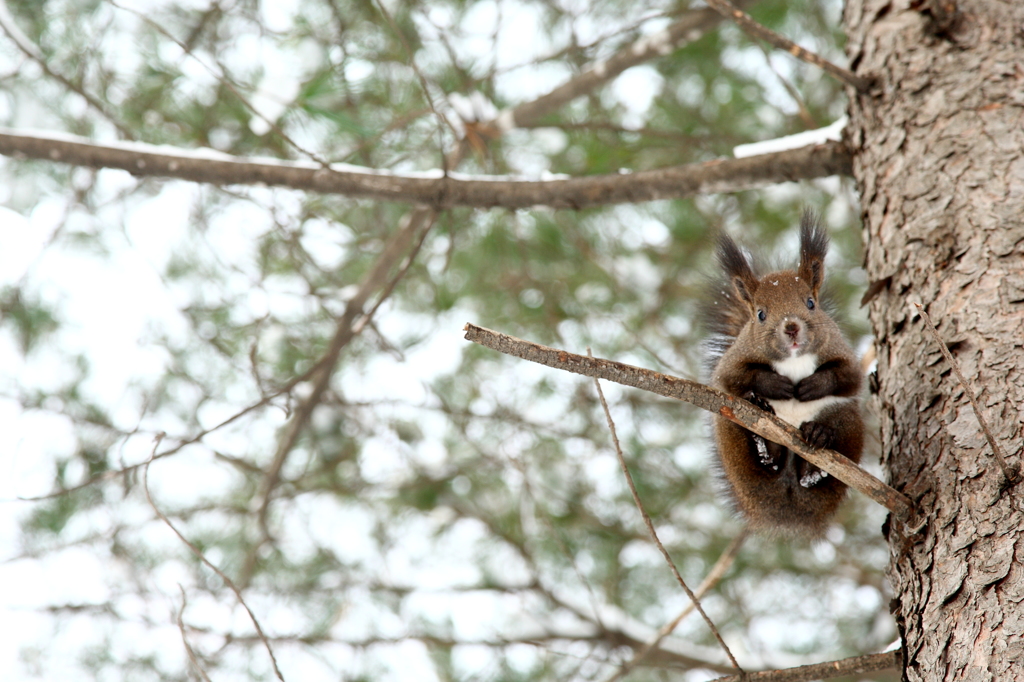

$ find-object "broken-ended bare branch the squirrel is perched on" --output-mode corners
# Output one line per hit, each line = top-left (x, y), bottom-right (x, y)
(464, 324), (918, 528)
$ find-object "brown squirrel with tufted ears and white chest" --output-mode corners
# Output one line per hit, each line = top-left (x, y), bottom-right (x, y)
(705, 212), (864, 538)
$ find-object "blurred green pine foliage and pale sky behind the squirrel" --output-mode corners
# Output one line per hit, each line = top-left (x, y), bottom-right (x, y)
(0, 0), (895, 680)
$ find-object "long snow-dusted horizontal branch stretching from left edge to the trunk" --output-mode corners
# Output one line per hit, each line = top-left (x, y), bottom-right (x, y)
(0, 128), (853, 209)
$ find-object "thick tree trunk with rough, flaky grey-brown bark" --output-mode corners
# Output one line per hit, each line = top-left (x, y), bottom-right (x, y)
(844, 0), (1024, 681)
